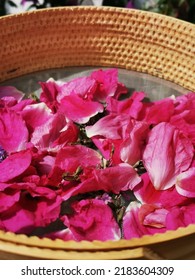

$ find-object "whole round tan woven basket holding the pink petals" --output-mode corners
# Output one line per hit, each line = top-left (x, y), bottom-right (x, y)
(0, 7), (195, 259)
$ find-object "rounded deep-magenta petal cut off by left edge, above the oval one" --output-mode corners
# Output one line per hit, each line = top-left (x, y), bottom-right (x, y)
(0, 109), (28, 152)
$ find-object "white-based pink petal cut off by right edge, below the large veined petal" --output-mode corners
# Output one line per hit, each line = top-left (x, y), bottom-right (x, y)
(175, 167), (195, 197)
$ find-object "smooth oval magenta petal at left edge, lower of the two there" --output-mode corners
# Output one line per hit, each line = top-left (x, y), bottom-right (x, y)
(0, 151), (32, 183)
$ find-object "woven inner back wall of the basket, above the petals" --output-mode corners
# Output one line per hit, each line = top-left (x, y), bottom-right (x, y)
(0, 7), (195, 91)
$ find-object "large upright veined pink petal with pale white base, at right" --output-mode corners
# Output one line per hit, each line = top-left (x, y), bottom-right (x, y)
(143, 123), (194, 190)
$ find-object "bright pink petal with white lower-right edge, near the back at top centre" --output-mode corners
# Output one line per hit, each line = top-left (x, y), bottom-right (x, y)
(59, 93), (104, 124)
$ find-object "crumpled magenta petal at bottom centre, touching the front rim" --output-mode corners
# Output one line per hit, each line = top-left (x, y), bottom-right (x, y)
(61, 199), (120, 241)
